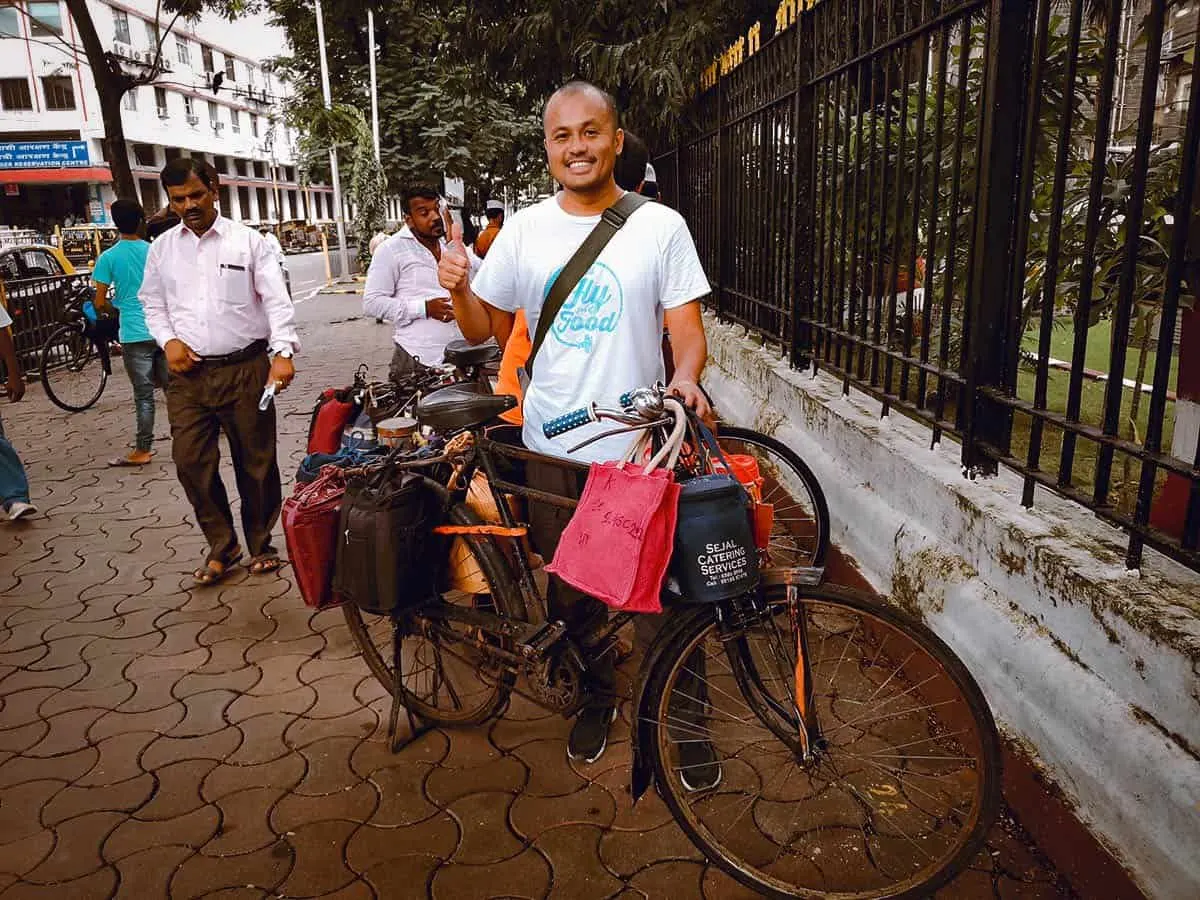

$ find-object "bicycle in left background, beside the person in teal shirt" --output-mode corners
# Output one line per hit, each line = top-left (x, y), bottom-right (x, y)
(38, 286), (116, 413)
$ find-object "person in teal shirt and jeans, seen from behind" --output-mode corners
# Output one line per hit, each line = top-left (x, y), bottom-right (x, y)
(91, 200), (167, 466)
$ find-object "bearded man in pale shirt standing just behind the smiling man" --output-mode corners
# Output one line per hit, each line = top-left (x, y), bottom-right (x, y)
(362, 185), (478, 382)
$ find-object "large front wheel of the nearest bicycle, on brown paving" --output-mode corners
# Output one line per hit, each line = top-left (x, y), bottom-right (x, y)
(647, 588), (1000, 900)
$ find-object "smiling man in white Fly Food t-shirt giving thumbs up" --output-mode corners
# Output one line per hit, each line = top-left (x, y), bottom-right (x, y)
(438, 82), (719, 776)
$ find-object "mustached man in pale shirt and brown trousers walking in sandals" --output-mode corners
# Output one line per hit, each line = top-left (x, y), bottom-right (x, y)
(139, 157), (300, 584)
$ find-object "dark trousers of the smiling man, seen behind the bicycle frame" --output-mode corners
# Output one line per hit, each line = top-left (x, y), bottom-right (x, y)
(526, 460), (707, 720)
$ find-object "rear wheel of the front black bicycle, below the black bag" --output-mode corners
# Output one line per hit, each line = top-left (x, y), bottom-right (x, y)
(342, 504), (524, 725)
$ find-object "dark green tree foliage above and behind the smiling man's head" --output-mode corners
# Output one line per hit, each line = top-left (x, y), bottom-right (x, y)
(269, 0), (774, 199)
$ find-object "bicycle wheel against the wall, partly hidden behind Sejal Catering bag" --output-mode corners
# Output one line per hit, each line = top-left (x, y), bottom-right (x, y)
(718, 425), (832, 568)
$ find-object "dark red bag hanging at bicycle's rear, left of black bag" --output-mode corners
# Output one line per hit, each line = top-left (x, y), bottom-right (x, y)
(282, 466), (346, 610)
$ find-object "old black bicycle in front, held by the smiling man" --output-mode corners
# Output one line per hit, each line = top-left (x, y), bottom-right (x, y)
(347, 386), (1000, 900)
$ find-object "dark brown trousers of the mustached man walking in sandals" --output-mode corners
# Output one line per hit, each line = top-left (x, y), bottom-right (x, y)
(167, 353), (283, 560)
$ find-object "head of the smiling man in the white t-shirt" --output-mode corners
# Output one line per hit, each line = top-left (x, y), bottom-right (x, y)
(545, 90), (625, 192)
